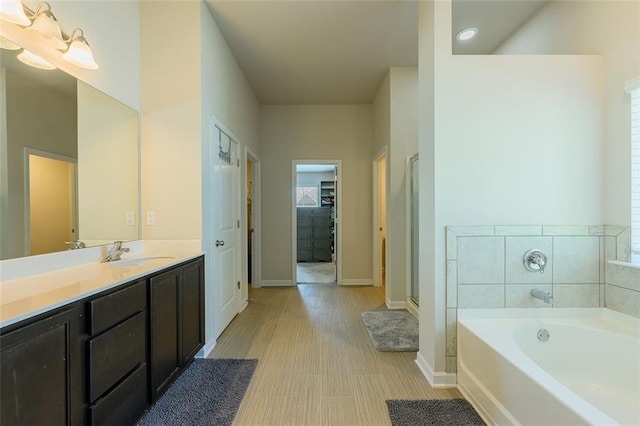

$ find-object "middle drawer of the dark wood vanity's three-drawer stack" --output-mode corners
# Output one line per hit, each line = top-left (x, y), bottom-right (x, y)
(88, 311), (146, 403)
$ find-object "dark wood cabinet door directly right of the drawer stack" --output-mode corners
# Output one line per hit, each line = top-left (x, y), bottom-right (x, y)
(149, 269), (181, 401)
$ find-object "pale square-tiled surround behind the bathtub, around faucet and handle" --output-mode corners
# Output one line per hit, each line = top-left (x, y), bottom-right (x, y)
(446, 225), (640, 373)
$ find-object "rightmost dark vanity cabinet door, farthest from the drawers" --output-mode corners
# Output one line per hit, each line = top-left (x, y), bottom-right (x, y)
(180, 259), (204, 367)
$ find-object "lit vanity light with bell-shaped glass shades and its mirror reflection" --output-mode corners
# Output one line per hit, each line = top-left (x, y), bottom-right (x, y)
(0, 0), (98, 70)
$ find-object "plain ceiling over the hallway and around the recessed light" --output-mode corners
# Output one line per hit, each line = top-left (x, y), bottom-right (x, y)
(206, 0), (541, 104)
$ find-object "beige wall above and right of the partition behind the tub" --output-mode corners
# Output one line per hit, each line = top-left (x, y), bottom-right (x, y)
(496, 1), (640, 225)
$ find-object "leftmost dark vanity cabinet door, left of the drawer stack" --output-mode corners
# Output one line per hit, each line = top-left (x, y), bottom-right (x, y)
(0, 308), (80, 425)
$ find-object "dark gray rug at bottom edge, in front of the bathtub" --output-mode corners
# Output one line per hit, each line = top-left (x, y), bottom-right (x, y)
(387, 399), (485, 426)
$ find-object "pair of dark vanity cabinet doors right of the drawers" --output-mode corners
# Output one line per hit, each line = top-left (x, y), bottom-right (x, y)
(149, 259), (204, 401)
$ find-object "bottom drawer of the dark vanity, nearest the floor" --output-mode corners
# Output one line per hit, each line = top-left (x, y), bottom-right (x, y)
(89, 363), (147, 426)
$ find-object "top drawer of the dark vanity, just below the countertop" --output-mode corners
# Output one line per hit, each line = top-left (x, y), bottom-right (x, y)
(89, 281), (147, 335)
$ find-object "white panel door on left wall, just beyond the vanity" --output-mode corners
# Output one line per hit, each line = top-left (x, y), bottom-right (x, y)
(210, 126), (240, 337)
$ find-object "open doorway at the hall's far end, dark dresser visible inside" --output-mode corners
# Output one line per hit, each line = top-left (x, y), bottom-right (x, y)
(292, 160), (342, 284)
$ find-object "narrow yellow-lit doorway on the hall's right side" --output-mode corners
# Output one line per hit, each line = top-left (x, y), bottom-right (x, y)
(373, 148), (387, 287)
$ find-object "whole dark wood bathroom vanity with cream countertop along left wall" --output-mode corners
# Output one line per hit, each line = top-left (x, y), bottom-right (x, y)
(0, 255), (205, 425)
